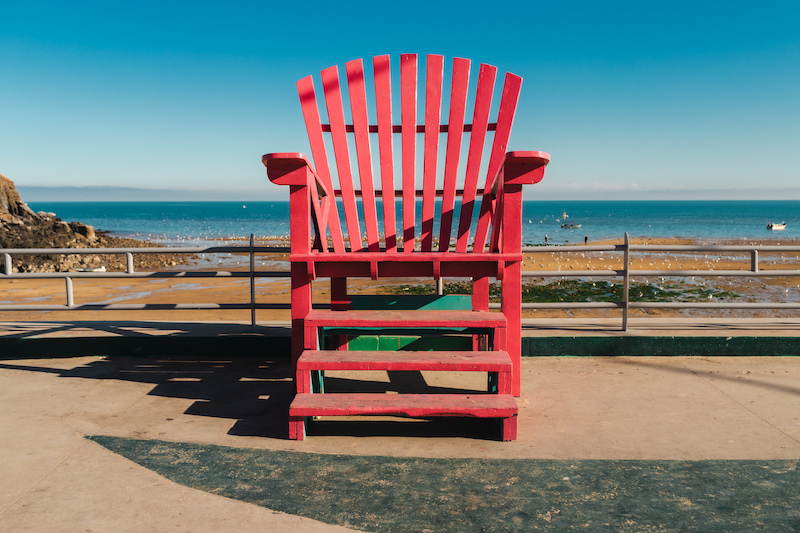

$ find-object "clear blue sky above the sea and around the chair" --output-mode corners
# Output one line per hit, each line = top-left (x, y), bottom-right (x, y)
(0, 0), (800, 200)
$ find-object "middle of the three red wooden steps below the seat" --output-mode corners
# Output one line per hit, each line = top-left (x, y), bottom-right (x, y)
(297, 350), (511, 372)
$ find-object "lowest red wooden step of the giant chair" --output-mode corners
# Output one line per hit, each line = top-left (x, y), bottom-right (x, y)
(289, 393), (518, 418)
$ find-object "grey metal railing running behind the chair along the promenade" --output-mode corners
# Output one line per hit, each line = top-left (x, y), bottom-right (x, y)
(0, 233), (800, 330)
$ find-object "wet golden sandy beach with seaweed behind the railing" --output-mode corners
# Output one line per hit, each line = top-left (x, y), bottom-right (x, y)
(0, 239), (800, 321)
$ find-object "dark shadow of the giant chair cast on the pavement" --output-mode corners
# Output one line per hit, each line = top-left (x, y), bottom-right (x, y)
(0, 353), (504, 440)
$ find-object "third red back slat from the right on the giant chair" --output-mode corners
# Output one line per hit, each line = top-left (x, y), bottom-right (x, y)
(439, 58), (470, 252)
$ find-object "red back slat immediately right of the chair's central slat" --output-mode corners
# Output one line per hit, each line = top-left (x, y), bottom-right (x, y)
(420, 54), (444, 252)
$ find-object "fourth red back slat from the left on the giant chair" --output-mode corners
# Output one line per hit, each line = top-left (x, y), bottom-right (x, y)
(376, 56), (397, 253)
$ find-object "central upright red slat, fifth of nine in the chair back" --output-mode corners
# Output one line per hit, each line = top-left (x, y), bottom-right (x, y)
(400, 54), (417, 253)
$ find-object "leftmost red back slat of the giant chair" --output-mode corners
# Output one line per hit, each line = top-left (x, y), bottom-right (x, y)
(297, 76), (344, 253)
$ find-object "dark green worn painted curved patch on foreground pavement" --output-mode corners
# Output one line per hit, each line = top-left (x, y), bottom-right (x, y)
(89, 436), (800, 532)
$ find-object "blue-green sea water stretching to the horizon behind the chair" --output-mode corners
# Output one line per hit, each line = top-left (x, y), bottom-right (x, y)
(30, 200), (800, 246)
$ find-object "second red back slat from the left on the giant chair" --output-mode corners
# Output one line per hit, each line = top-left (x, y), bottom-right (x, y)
(322, 67), (363, 252)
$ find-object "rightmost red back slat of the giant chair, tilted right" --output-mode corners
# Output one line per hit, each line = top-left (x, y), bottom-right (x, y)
(473, 73), (522, 252)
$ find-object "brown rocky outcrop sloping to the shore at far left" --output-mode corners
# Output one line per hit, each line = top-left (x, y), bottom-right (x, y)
(0, 174), (188, 272)
